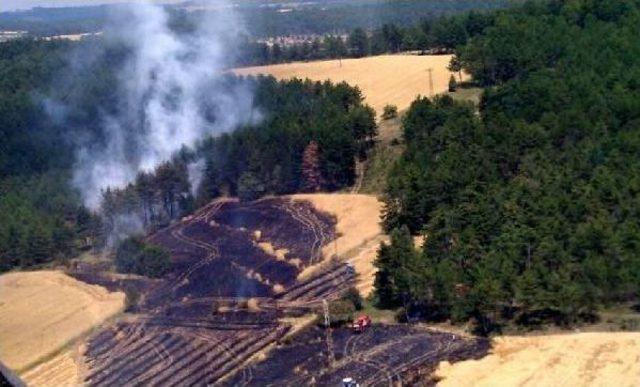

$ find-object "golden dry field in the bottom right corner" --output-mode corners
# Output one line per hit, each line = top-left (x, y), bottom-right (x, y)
(437, 332), (640, 387)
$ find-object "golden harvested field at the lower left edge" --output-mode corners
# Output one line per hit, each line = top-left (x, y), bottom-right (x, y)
(0, 271), (125, 373)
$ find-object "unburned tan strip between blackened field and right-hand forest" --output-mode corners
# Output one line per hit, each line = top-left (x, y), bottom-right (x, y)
(292, 194), (386, 297)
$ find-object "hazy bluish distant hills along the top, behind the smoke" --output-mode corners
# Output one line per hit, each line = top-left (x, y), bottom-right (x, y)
(0, 0), (514, 37)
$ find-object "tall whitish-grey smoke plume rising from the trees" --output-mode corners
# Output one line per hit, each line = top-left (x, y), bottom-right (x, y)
(73, 3), (259, 210)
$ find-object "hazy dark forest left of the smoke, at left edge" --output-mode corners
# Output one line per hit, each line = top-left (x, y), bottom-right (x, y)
(0, 40), (98, 270)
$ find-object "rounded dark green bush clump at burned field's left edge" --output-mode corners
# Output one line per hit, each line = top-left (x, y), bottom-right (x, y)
(116, 236), (171, 278)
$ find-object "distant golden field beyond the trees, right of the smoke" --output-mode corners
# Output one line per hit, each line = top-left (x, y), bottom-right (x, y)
(233, 54), (468, 114)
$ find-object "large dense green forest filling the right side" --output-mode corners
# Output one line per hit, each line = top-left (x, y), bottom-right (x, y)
(376, 0), (640, 332)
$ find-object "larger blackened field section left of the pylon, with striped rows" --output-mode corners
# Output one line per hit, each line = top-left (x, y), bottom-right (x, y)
(76, 199), (355, 385)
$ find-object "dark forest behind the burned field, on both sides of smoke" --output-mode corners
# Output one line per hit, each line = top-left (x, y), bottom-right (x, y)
(0, 39), (376, 271)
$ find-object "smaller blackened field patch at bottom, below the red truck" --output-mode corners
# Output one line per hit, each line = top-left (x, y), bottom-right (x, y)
(222, 325), (489, 386)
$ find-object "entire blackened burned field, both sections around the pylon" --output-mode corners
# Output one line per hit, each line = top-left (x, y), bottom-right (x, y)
(76, 199), (486, 385)
